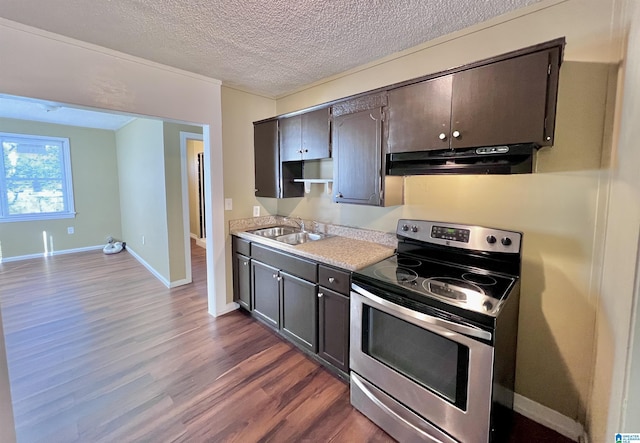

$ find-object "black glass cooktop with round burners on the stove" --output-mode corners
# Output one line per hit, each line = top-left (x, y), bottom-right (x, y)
(353, 255), (516, 317)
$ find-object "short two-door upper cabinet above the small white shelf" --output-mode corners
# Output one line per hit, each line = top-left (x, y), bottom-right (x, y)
(279, 108), (331, 162)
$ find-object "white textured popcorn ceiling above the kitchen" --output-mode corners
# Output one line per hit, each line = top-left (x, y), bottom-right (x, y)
(0, 0), (539, 97)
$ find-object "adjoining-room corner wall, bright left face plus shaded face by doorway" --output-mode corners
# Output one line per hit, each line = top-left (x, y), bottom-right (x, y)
(116, 119), (202, 286)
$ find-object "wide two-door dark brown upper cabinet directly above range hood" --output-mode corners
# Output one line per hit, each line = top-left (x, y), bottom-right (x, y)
(386, 47), (560, 153)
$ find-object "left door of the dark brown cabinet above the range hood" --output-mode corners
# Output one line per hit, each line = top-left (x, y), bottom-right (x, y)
(387, 75), (452, 154)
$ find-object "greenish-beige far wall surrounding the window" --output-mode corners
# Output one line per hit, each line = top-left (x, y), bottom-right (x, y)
(0, 118), (122, 258)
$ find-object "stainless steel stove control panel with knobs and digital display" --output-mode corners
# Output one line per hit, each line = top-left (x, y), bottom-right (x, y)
(396, 219), (522, 253)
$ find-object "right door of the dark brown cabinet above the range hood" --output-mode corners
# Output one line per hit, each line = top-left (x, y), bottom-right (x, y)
(451, 51), (549, 148)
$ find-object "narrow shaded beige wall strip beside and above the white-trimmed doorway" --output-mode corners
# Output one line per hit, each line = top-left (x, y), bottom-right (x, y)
(163, 123), (202, 283)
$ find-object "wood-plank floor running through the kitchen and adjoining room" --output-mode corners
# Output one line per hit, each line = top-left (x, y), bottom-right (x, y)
(0, 244), (570, 443)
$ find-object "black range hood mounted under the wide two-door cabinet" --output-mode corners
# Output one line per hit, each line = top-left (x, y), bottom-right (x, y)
(386, 144), (537, 175)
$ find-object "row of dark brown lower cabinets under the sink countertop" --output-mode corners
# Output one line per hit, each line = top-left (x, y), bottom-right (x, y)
(233, 236), (351, 377)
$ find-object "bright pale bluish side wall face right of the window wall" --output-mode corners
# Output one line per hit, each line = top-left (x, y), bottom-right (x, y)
(116, 118), (170, 281)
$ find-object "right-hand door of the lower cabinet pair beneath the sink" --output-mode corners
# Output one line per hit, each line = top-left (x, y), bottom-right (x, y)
(280, 272), (318, 352)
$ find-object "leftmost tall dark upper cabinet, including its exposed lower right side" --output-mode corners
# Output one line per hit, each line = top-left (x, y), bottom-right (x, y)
(253, 119), (304, 198)
